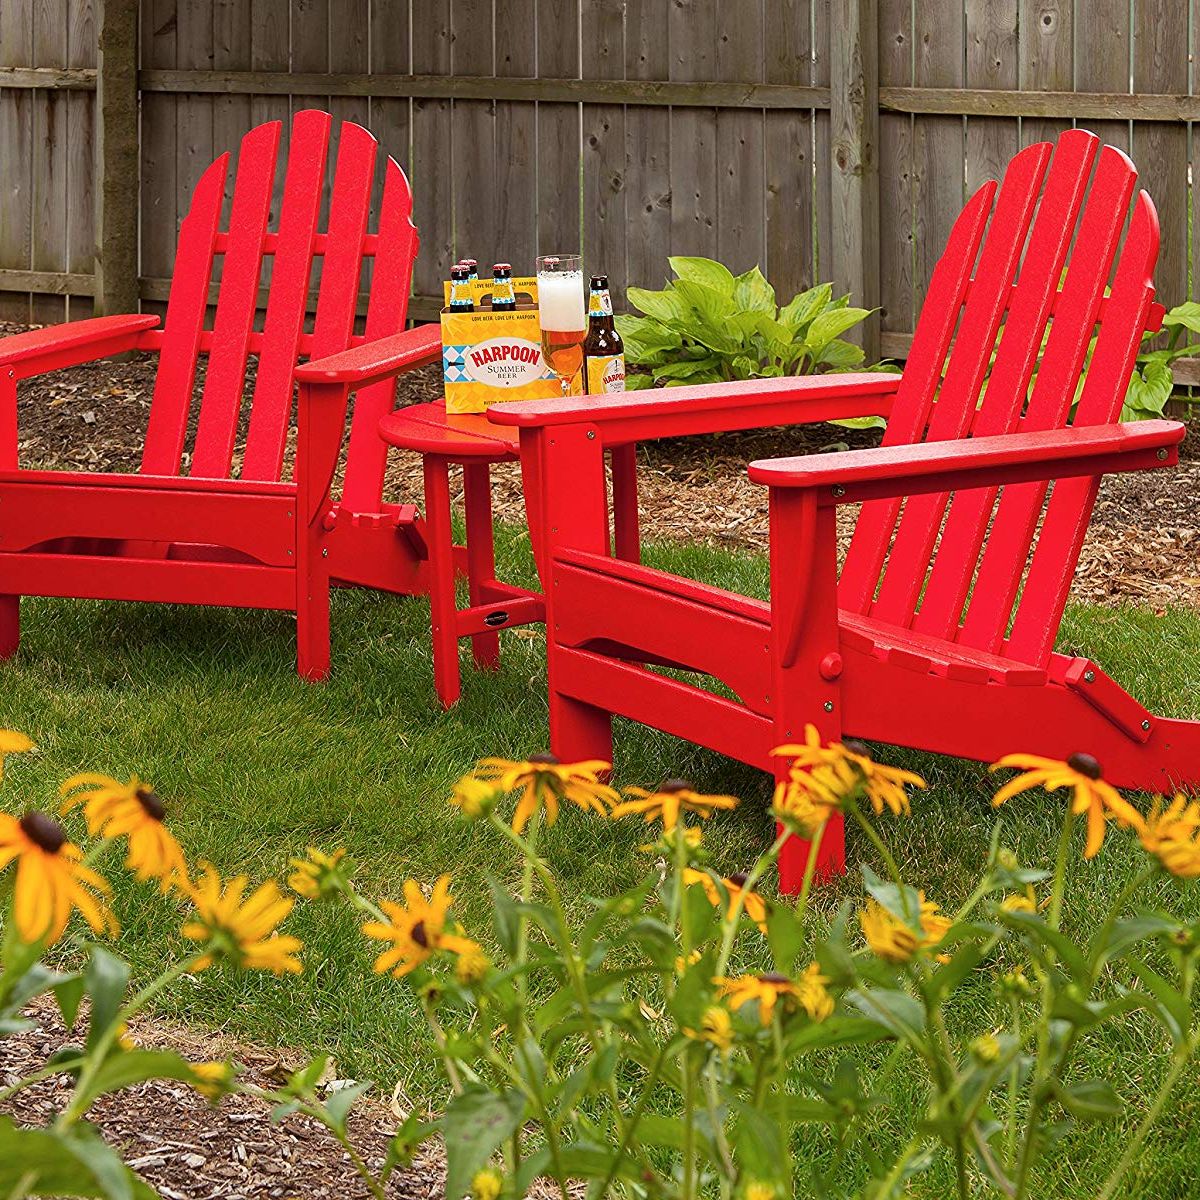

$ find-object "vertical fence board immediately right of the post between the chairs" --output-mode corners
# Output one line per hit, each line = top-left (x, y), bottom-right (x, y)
(878, 0), (916, 334)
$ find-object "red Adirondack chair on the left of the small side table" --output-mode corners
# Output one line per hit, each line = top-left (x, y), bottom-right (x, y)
(0, 112), (440, 679)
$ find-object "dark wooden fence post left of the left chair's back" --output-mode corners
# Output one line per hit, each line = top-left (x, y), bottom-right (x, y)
(95, 0), (140, 313)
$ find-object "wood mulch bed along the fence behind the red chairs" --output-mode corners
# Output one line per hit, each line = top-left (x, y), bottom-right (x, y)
(0, 323), (1200, 608)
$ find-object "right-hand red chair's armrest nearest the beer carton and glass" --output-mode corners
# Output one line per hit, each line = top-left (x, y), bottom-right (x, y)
(487, 371), (900, 445)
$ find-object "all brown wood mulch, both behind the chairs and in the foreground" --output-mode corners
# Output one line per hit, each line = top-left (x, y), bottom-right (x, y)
(0, 323), (1200, 1200)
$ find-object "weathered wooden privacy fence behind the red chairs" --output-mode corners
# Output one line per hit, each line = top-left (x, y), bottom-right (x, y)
(0, 0), (1200, 382)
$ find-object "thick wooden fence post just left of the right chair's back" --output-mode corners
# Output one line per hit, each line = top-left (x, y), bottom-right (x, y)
(829, 0), (880, 362)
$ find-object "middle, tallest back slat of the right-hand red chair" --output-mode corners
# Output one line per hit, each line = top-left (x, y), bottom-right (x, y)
(912, 131), (1097, 637)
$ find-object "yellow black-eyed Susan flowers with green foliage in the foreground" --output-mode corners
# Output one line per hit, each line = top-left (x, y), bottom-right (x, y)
(0, 728), (1200, 1200)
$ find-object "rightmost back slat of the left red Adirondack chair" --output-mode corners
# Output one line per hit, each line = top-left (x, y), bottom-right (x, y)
(342, 158), (419, 511)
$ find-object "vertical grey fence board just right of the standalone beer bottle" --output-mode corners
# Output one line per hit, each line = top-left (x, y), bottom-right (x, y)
(613, 0), (674, 292)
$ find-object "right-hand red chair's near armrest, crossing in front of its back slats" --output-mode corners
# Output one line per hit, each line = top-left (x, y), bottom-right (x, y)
(750, 421), (1184, 504)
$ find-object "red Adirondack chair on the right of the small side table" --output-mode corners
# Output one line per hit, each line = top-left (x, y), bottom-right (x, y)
(490, 131), (1200, 889)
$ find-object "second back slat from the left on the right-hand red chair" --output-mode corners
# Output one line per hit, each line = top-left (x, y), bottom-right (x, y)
(870, 143), (1050, 625)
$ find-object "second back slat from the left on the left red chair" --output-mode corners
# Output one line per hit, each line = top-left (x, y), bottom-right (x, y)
(191, 121), (282, 479)
